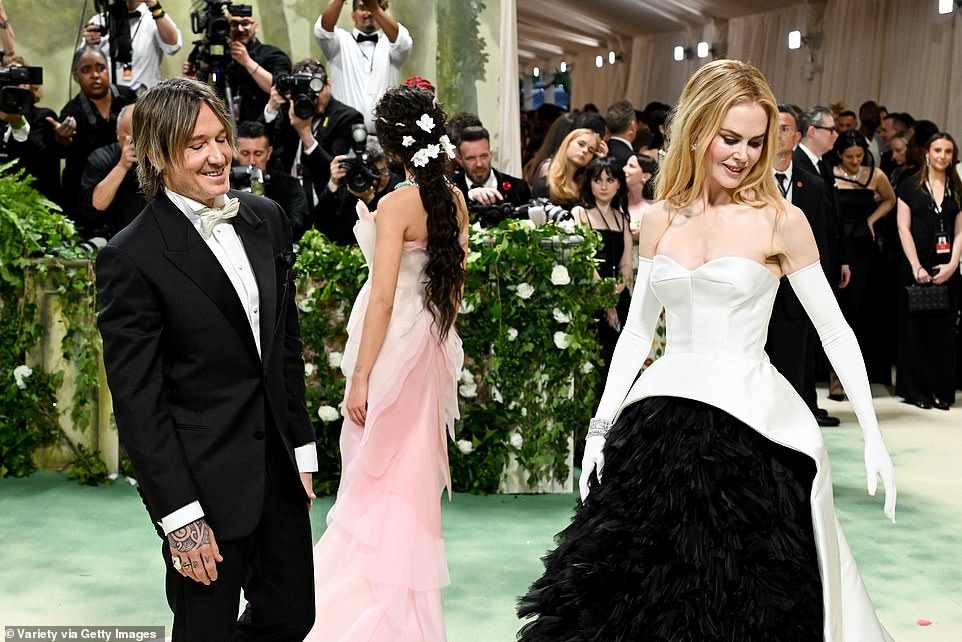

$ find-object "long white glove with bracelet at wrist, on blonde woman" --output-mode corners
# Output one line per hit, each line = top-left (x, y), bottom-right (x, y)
(578, 257), (662, 501)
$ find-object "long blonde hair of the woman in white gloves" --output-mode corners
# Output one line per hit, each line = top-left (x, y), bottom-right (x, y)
(655, 60), (784, 211)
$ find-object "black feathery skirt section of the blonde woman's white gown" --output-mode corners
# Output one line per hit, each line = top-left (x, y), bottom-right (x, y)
(518, 397), (823, 642)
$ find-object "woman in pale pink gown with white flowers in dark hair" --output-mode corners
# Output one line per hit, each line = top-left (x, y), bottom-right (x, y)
(306, 86), (468, 642)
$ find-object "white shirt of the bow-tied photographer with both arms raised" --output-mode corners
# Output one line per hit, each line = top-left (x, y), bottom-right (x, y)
(314, 18), (414, 133)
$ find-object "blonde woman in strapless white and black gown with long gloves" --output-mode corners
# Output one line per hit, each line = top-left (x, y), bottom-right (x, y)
(518, 60), (895, 642)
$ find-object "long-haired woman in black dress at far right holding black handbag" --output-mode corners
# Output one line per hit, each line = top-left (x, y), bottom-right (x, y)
(895, 132), (962, 410)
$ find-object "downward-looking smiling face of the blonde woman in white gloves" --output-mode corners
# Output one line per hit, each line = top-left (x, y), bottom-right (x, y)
(705, 103), (768, 190)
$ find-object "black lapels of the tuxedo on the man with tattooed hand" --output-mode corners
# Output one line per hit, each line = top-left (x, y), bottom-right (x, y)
(152, 193), (276, 361)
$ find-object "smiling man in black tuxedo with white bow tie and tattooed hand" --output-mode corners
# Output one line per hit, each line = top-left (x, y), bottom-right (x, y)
(97, 78), (317, 642)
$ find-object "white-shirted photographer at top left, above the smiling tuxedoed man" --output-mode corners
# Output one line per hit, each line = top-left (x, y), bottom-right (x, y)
(83, 0), (184, 91)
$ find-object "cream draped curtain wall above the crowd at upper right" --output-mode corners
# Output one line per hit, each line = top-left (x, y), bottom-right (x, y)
(584, 0), (962, 139)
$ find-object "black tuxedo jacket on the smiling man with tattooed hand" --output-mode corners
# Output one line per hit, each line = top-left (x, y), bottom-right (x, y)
(97, 190), (314, 540)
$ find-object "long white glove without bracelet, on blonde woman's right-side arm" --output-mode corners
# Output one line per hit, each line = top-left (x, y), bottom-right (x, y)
(788, 262), (897, 523)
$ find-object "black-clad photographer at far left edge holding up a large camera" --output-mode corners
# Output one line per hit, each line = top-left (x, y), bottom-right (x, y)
(0, 56), (62, 203)
